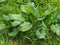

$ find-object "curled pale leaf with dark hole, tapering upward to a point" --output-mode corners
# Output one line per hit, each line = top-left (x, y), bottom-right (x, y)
(36, 22), (48, 39)
